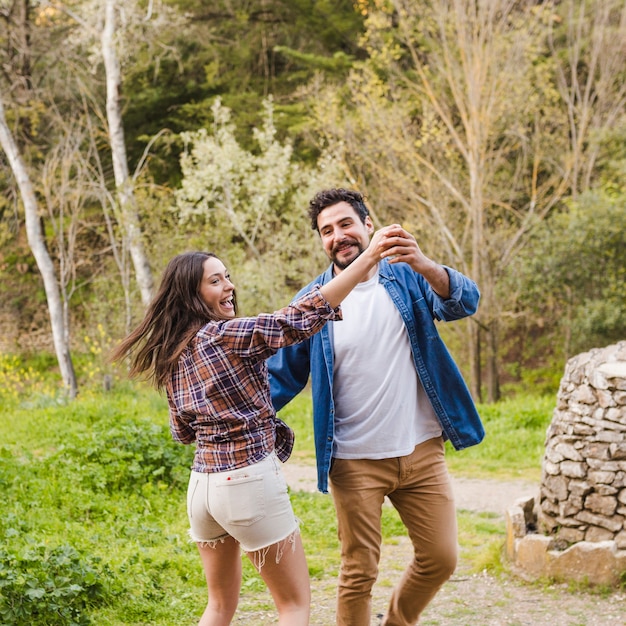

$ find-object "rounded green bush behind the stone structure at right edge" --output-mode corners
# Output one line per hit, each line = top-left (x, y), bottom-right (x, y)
(507, 191), (626, 359)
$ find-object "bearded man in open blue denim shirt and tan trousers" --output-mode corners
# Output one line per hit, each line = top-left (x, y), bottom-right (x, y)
(268, 189), (484, 626)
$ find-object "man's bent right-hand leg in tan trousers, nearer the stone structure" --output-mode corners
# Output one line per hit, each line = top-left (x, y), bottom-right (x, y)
(383, 438), (458, 626)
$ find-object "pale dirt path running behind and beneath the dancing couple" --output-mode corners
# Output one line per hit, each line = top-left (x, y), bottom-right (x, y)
(260, 462), (626, 626)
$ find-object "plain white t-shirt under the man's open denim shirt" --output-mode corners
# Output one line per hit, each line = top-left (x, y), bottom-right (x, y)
(331, 274), (442, 459)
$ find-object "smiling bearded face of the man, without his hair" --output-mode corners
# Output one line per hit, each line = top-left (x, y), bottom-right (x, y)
(317, 201), (374, 272)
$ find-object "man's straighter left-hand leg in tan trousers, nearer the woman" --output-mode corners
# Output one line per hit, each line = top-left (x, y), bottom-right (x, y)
(330, 459), (397, 626)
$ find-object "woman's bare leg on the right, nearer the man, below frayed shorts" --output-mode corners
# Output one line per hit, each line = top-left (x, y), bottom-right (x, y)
(248, 532), (311, 626)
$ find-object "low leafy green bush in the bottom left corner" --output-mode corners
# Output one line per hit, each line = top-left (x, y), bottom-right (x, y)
(0, 545), (108, 626)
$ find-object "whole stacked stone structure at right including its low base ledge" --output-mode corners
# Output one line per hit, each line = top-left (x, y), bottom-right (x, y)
(506, 341), (626, 585)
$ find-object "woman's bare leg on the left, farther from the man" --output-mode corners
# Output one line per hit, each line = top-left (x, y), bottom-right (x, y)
(196, 537), (241, 626)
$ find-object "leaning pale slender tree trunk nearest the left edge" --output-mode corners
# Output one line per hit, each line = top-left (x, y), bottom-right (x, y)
(0, 99), (78, 398)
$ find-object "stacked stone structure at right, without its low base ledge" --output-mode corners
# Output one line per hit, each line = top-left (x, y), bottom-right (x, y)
(537, 341), (626, 549)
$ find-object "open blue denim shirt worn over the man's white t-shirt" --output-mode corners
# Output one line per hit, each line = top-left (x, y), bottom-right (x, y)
(267, 260), (485, 493)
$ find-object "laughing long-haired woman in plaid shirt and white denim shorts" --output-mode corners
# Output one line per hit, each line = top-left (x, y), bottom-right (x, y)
(113, 225), (399, 626)
